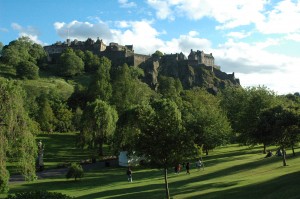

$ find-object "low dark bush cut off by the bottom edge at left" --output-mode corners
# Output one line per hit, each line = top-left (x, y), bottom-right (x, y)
(6, 191), (73, 199)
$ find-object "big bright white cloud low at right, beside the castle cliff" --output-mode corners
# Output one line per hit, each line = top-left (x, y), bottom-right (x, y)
(214, 40), (300, 94)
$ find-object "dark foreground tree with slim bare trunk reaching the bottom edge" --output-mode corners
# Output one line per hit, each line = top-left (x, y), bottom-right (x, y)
(135, 99), (194, 198)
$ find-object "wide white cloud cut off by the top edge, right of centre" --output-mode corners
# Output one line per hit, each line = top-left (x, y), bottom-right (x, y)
(147, 0), (267, 29)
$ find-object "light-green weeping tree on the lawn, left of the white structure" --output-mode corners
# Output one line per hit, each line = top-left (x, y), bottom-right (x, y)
(80, 99), (118, 156)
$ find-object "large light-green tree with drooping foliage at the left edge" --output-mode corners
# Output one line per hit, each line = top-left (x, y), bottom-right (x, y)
(0, 79), (37, 192)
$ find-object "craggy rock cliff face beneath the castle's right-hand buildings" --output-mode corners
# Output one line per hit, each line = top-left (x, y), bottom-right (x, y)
(140, 58), (240, 94)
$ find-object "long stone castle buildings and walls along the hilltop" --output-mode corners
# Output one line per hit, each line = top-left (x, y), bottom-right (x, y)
(44, 38), (219, 69)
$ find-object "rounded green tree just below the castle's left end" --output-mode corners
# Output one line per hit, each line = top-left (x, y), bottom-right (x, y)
(59, 48), (84, 77)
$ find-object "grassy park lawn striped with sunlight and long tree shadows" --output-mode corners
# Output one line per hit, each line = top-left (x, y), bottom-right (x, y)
(2, 134), (300, 199)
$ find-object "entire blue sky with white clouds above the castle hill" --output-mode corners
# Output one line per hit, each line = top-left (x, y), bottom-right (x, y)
(0, 0), (300, 94)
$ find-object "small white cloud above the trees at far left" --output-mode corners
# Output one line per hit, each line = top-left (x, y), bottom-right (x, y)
(11, 23), (44, 45)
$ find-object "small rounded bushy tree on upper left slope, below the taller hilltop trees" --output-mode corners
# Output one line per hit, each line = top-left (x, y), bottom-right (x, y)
(16, 61), (39, 79)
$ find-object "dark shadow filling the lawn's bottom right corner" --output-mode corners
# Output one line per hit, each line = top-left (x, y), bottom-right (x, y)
(181, 171), (300, 199)
